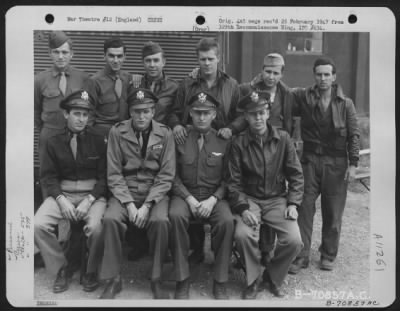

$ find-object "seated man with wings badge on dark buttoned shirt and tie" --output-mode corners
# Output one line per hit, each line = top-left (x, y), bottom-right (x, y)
(169, 91), (234, 299)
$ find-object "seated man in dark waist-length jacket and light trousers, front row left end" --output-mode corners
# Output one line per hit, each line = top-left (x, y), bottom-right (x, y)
(34, 90), (107, 293)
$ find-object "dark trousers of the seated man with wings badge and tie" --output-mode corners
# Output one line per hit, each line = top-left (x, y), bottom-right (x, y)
(169, 196), (234, 282)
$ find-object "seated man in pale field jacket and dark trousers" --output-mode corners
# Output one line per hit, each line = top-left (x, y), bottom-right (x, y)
(100, 83), (175, 299)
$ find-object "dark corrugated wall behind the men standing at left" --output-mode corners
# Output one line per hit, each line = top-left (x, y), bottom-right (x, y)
(33, 30), (220, 176)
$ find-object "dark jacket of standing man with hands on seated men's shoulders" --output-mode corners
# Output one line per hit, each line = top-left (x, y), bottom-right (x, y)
(168, 71), (247, 134)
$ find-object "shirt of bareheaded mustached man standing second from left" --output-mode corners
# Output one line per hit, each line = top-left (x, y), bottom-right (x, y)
(90, 67), (132, 126)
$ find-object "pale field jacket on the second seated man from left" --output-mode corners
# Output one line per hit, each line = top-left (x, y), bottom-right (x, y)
(107, 120), (175, 204)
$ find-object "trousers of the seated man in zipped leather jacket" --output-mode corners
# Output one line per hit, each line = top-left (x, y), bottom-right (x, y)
(234, 197), (303, 286)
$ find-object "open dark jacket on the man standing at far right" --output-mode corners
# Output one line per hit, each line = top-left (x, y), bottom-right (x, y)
(293, 84), (360, 166)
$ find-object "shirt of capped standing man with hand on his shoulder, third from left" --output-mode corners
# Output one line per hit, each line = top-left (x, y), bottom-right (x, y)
(134, 72), (178, 124)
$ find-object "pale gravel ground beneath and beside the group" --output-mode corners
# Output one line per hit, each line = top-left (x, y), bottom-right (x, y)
(34, 183), (370, 306)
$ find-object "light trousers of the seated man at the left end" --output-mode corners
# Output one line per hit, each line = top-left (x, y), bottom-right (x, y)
(34, 192), (107, 274)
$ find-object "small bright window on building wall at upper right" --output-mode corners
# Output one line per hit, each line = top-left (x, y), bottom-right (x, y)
(286, 32), (323, 54)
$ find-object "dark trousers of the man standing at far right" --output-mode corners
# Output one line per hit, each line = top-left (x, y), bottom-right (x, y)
(298, 152), (347, 260)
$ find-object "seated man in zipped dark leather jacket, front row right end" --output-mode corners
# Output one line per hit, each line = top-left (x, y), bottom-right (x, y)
(228, 91), (304, 299)
